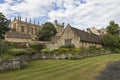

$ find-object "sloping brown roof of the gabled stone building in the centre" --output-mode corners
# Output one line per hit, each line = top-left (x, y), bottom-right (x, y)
(71, 27), (102, 44)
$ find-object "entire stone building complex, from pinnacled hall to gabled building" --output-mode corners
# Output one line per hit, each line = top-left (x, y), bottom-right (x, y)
(5, 17), (102, 49)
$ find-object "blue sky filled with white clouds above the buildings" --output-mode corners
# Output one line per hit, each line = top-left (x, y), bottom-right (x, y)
(0, 0), (120, 29)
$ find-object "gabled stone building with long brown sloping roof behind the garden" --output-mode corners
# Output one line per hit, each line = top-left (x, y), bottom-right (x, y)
(48, 24), (102, 49)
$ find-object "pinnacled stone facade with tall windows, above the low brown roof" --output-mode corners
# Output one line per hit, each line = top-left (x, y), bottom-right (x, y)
(7, 17), (41, 40)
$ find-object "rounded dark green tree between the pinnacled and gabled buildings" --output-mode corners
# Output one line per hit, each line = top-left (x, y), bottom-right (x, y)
(38, 22), (57, 41)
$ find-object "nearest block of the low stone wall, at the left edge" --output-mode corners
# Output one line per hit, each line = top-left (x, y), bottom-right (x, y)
(0, 58), (21, 71)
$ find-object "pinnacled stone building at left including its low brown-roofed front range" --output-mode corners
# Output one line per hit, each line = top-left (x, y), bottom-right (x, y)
(5, 17), (41, 42)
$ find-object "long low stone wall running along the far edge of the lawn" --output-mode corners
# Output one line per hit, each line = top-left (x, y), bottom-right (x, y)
(0, 52), (109, 70)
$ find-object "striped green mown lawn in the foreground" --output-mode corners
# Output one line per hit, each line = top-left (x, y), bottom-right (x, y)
(0, 54), (120, 80)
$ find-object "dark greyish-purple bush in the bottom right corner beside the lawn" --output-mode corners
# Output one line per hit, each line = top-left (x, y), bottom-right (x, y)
(96, 61), (120, 80)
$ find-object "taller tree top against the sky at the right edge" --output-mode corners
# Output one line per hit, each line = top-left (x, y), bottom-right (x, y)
(107, 21), (120, 35)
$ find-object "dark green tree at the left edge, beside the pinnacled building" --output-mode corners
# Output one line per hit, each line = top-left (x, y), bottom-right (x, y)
(0, 13), (9, 39)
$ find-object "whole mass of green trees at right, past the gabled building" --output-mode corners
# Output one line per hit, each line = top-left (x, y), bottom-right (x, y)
(102, 21), (120, 50)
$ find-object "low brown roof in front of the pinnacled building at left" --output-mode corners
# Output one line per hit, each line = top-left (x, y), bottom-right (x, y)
(5, 32), (31, 39)
